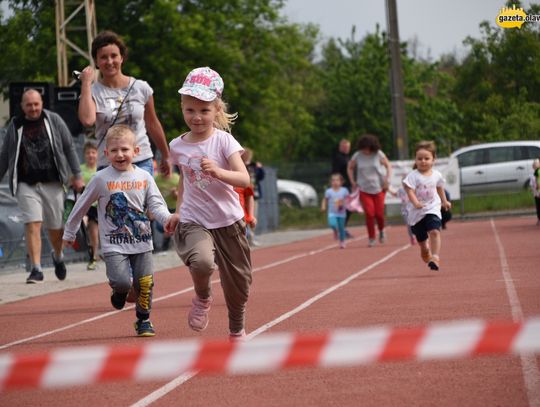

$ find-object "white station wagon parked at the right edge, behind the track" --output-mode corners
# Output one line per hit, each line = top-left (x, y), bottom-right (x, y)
(452, 141), (540, 193)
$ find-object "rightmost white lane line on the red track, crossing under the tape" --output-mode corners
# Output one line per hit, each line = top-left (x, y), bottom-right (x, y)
(490, 218), (540, 407)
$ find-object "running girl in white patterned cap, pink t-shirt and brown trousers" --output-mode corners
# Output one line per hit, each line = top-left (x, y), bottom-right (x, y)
(166, 67), (251, 341)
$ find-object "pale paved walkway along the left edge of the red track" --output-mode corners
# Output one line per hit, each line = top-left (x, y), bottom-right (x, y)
(0, 229), (330, 304)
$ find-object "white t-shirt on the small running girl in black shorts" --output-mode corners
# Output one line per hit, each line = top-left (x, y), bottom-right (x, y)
(403, 170), (445, 226)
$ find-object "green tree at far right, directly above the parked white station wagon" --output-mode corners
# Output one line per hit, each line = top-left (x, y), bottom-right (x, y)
(452, 4), (540, 145)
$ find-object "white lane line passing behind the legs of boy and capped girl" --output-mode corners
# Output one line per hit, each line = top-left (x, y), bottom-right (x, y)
(0, 236), (365, 350)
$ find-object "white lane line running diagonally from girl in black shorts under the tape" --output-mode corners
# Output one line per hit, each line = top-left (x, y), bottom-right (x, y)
(130, 244), (411, 407)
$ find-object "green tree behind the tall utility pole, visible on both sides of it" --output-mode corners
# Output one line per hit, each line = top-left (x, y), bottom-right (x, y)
(314, 27), (461, 157)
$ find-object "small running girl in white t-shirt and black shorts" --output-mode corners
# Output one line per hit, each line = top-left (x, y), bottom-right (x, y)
(403, 141), (452, 270)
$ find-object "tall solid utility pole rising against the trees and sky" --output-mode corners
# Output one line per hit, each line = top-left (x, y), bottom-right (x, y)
(386, 0), (409, 160)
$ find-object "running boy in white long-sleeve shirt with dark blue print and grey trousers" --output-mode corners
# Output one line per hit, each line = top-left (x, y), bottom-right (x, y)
(63, 125), (171, 336)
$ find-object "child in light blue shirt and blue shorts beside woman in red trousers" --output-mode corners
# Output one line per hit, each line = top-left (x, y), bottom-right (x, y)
(321, 173), (349, 249)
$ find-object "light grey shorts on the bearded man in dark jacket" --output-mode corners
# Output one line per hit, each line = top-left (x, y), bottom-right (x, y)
(17, 182), (65, 230)
